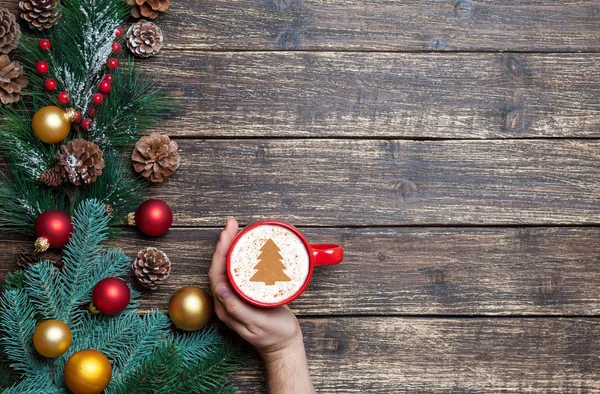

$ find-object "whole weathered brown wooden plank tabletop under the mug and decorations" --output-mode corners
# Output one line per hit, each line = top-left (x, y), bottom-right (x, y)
(0, 0), (600, 393)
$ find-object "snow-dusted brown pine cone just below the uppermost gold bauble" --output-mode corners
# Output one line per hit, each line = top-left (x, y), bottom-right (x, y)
(56, 139), (104, 186)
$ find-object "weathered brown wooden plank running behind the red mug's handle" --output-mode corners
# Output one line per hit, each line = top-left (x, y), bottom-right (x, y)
(0, 228), (600, 315)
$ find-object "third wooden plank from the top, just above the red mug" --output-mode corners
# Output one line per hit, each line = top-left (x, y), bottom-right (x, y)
(143, 139), (600, 226)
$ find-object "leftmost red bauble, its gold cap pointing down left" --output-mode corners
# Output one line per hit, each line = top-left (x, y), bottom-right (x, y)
(34, 211), (73, 251)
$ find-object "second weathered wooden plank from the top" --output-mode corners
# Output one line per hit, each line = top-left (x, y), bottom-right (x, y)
(142, 51), (600, 139)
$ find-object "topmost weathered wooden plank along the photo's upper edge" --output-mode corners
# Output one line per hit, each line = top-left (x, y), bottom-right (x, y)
(152, 0), (600, 51)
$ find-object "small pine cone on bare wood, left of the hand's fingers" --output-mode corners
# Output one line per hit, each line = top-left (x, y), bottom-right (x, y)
(131, 248), (171, 290)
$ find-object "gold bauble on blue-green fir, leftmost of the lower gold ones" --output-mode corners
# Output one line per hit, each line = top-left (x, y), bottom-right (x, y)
(33, 320), (73, 358)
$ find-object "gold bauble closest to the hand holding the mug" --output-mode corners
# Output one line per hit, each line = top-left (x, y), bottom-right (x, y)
(169, 286), (213, 331)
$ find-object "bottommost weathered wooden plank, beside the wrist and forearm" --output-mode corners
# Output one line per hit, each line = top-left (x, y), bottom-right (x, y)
(236, 318), (600, 394)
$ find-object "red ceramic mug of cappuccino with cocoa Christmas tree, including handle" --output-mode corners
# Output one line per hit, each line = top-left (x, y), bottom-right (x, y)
(227, 220), (344, 308)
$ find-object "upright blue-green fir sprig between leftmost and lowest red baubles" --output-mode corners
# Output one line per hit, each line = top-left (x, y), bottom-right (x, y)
(59, 200), (110, 325)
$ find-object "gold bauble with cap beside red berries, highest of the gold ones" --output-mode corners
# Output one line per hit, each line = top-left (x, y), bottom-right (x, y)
(31, 105), (77, 144)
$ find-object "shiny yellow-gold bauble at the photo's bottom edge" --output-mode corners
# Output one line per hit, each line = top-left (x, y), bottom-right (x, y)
(64, 349), (112, 394)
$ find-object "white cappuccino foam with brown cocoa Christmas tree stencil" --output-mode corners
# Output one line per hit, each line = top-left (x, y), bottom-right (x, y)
(230, 224), (310, 304)
